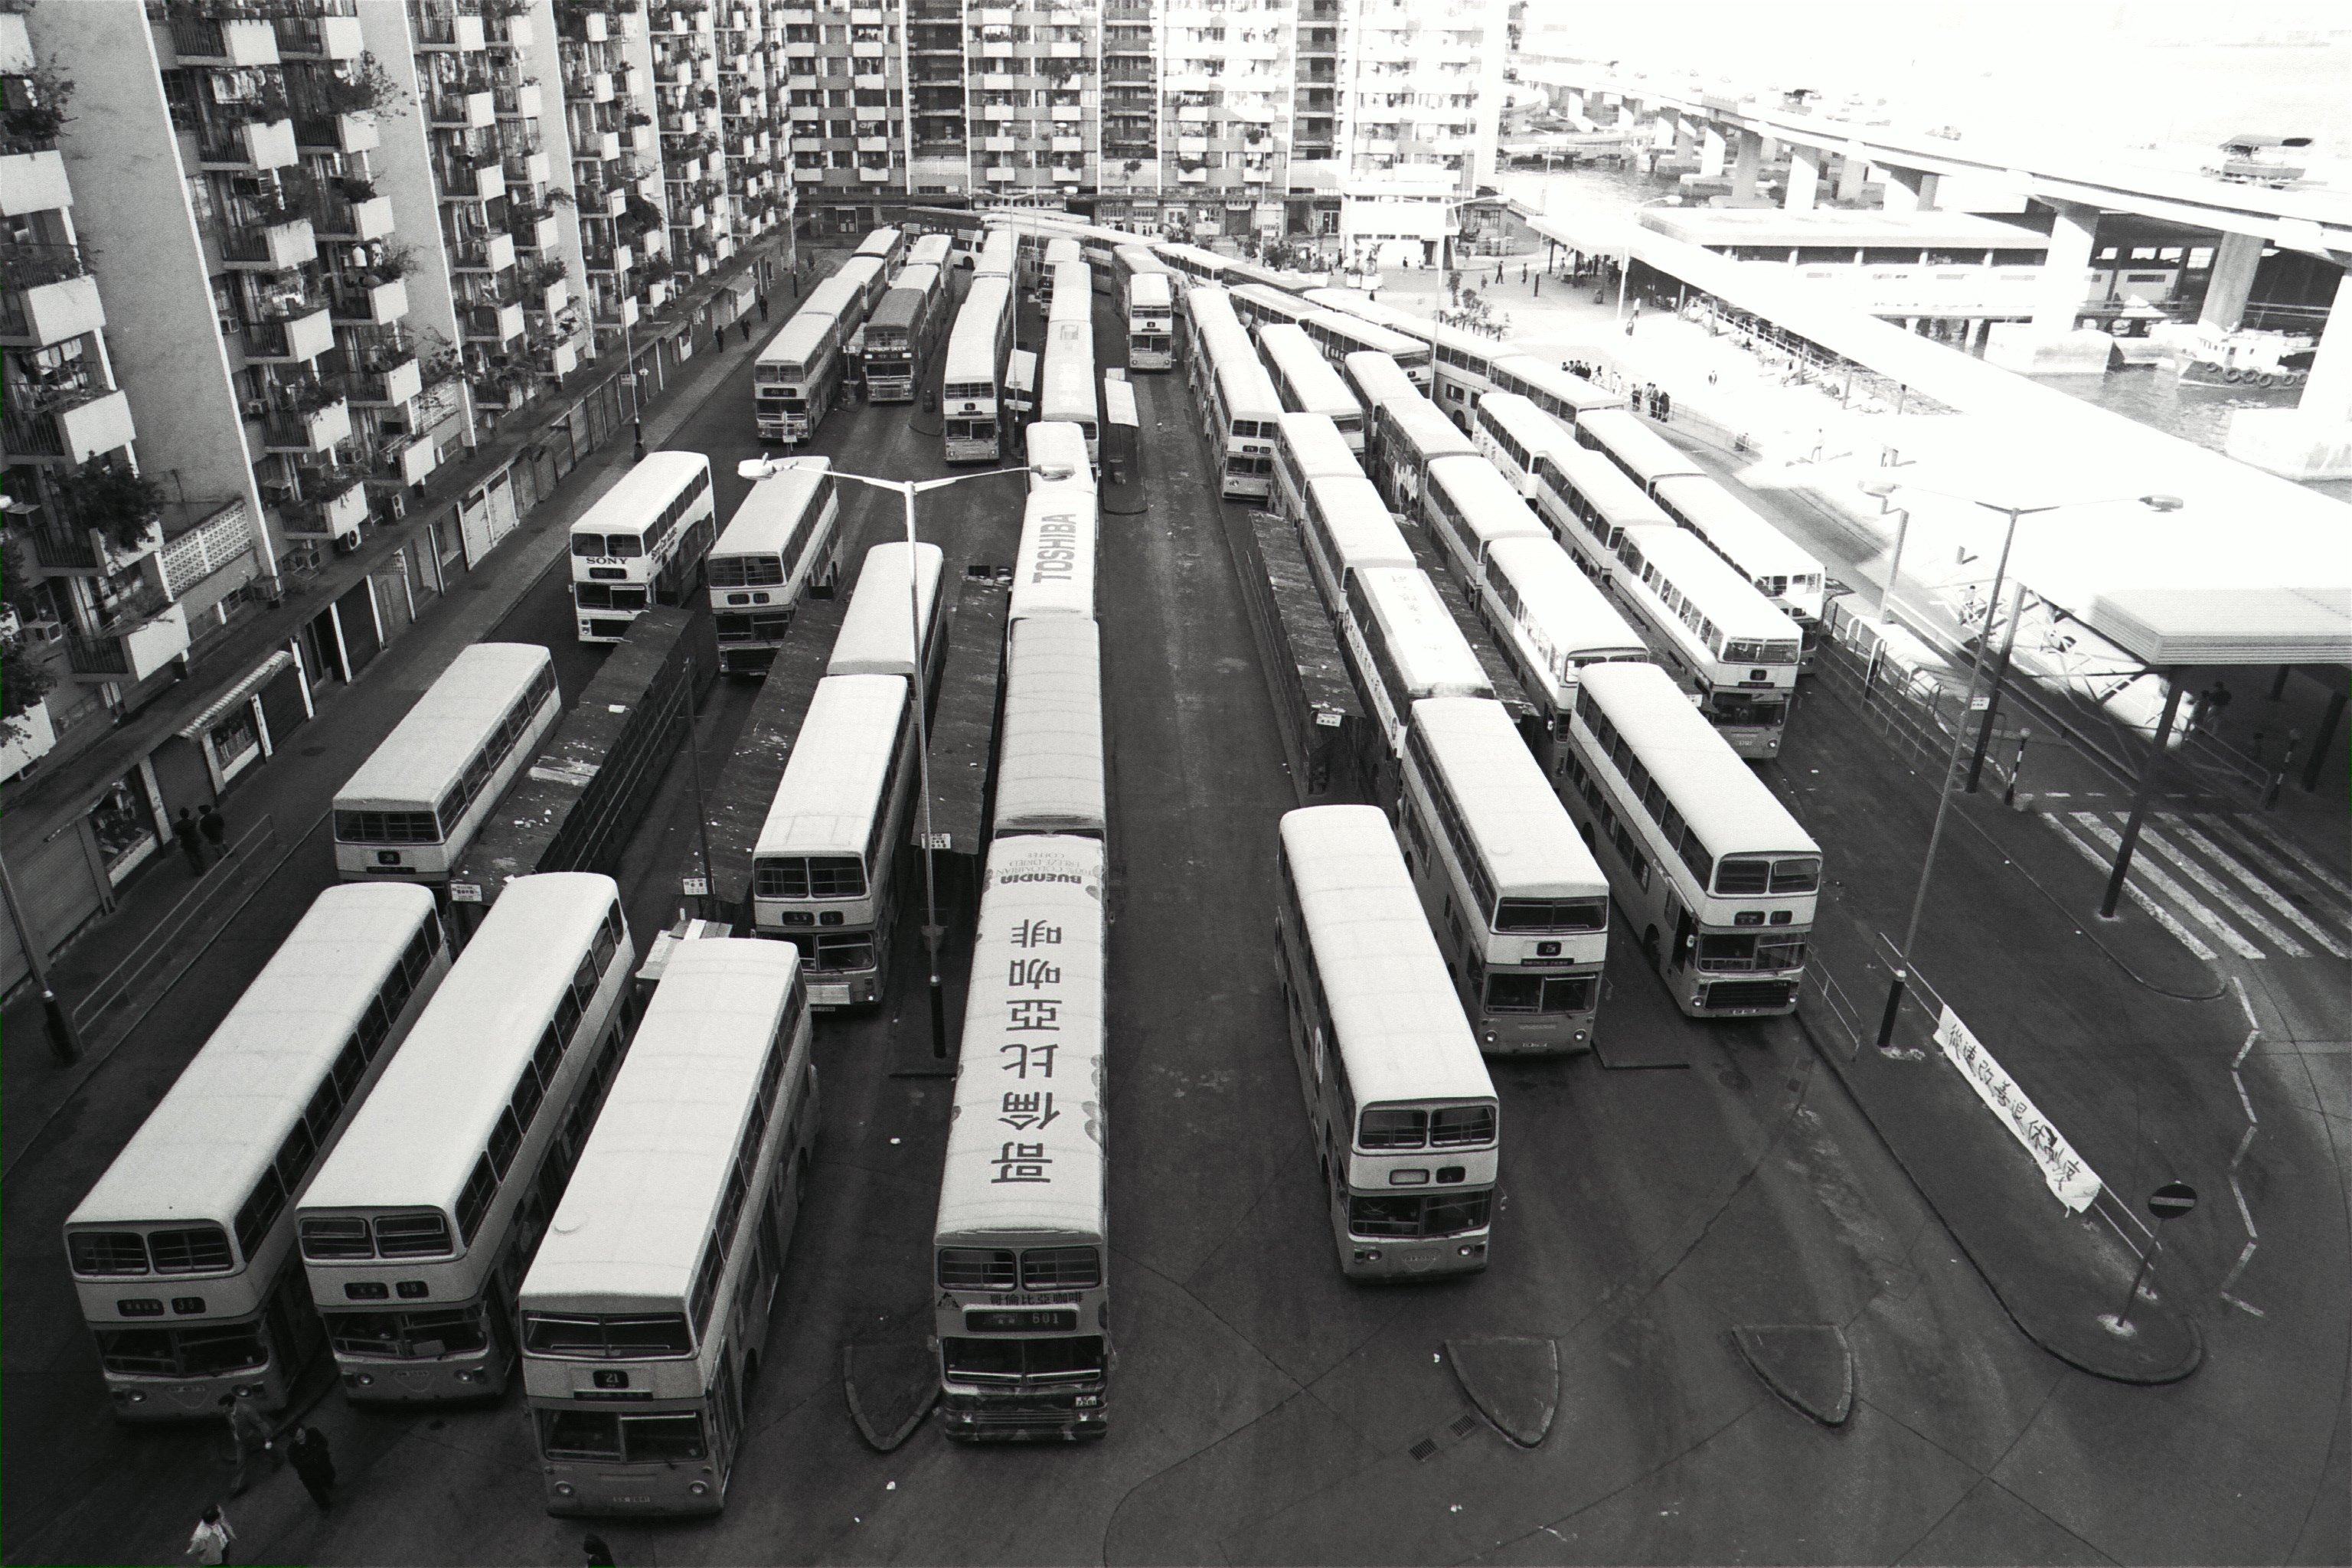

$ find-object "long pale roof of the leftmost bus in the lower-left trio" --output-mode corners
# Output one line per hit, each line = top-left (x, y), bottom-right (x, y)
(66, 881), (435, 1230)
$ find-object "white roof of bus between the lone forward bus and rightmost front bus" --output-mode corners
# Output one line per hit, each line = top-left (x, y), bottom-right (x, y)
(1413, 696), (1609, 893)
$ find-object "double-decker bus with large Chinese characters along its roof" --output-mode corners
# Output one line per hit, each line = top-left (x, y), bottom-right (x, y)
(932, 835), (1112, 1441)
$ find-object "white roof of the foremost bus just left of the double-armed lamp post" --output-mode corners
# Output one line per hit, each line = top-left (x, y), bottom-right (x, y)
(753, 675), (908, 856)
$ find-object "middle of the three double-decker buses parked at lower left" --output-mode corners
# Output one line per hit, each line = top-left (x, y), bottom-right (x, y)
(294, 872), (638, 1401)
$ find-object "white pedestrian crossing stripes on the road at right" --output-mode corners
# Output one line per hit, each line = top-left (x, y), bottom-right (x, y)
(2041, 811), (2352, 959)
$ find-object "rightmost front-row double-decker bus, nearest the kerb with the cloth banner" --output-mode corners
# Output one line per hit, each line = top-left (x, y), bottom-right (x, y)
(1562, 665), (1821, 1018)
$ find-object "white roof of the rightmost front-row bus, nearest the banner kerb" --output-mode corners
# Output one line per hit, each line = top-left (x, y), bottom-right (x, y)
(1578, 663), (1821, 858)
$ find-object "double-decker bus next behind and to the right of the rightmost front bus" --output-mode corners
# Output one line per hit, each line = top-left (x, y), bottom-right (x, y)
(1615, 527), (1804, 760)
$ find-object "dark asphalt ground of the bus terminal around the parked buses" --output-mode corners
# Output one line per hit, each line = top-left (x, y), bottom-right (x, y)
(5, 276), (2352, 1563)
